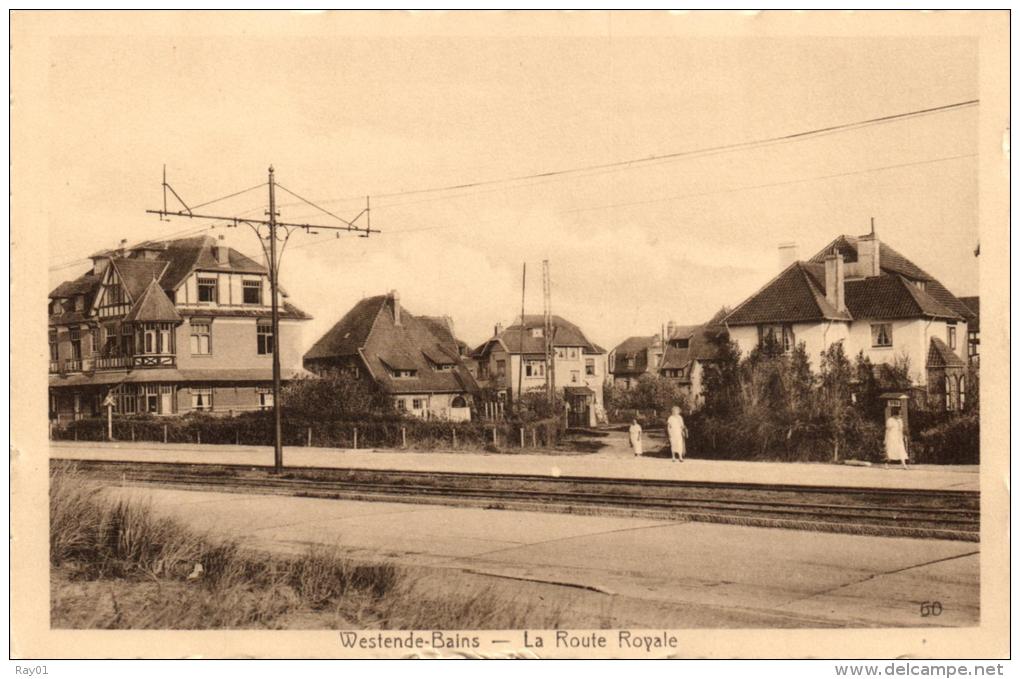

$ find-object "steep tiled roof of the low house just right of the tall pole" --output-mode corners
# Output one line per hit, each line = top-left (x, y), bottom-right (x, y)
(305, 296), (477, 394)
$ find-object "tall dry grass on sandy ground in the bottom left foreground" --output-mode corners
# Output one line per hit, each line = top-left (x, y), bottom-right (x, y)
(50, 468), (562, 629)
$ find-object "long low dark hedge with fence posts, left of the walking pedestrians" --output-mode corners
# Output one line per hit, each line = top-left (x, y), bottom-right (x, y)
(52, 412), (561, 450)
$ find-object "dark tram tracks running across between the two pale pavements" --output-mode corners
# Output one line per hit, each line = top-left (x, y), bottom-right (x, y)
(52, 461), (980, 541)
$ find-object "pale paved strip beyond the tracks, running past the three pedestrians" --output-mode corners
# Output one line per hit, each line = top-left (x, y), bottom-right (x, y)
(50, 441), (980, 490)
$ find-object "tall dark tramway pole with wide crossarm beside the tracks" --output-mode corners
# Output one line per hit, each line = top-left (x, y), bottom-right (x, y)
(146, 165), (380, 474)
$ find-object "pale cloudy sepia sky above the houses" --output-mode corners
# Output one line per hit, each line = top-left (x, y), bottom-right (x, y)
(37, 16), (980, 349)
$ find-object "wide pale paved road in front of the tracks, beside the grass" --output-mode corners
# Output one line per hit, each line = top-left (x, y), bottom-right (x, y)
(107, 486), (979, 628)
